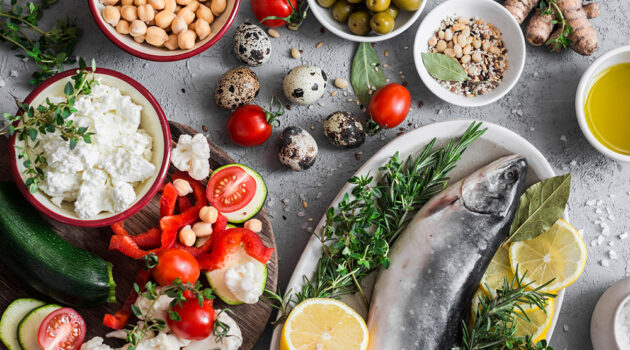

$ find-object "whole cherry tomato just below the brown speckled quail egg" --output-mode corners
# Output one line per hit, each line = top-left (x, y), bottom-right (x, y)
(227, 105), (276, 146)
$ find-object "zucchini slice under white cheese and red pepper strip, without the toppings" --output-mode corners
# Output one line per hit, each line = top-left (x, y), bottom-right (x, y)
(206, 248), (267, 305)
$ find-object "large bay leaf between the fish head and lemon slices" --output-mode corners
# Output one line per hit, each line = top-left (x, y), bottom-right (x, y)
(508, 174), (571, 242)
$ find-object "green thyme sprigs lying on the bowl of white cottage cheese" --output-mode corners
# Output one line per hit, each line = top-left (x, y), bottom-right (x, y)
(0, 59), (98, 193)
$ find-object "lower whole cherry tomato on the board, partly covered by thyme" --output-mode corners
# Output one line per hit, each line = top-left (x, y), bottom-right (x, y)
(166, 298), (214, 340)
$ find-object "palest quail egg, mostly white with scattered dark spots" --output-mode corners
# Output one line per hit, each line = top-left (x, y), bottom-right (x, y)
(282, 65), (328, 105)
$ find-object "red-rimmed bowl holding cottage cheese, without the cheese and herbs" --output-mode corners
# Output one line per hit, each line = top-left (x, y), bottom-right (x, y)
(9, 68), (171, 227)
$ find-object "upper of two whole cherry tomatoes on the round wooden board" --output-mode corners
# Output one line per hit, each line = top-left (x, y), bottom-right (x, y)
(151, 249), (200, 286)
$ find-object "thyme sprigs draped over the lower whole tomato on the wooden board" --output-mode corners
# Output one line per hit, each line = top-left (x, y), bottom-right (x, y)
(125, 278), (230, 350)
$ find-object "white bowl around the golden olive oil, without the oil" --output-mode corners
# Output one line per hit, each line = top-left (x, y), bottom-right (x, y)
(575, 45), (630, 162)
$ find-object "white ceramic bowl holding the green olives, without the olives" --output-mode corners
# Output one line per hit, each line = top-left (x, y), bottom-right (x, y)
(308, 0), (429, 43)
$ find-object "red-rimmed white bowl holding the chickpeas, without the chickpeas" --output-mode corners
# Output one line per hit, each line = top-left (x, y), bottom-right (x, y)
(88, 0), (241, 62)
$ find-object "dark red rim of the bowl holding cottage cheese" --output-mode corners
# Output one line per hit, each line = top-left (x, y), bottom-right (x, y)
(9, 68), (171, 227)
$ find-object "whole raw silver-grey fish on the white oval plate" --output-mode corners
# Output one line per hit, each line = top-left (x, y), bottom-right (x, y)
(368, 155), (527, 350)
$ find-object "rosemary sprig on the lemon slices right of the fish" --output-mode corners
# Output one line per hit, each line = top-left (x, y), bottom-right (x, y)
(460, 268), (556, 350)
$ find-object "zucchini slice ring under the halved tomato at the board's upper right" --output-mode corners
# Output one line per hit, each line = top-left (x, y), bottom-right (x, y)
(208, 164), (267, 224)
